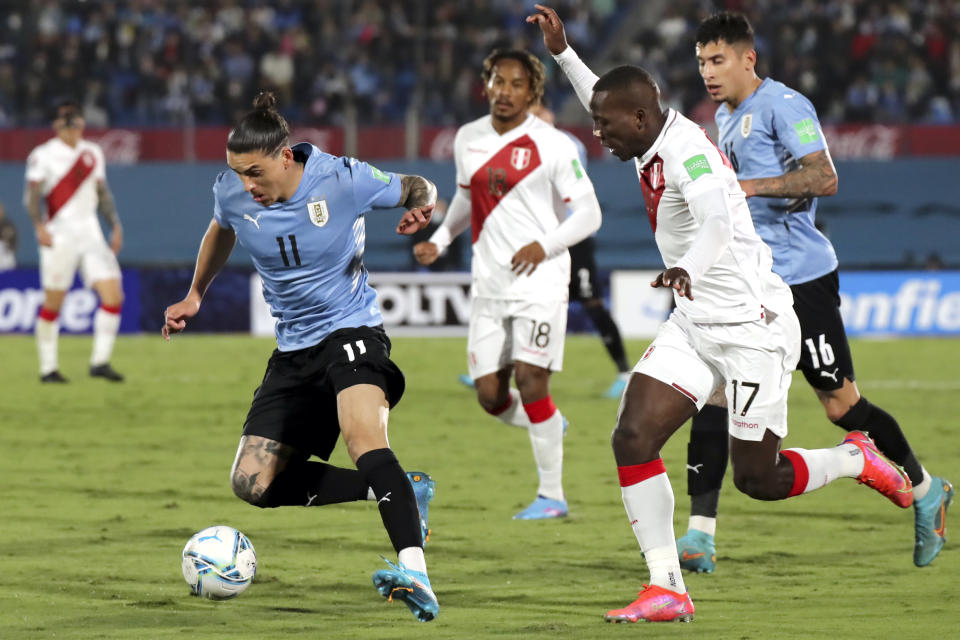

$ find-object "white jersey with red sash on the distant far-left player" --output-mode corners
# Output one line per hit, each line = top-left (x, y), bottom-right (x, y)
(26, 138), (106, 237)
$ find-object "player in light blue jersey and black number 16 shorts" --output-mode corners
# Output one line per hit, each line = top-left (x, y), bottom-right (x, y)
(678, 12), (954, 572)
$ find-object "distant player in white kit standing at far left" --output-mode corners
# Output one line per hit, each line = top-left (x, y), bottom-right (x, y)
(24, 100), (123, 383)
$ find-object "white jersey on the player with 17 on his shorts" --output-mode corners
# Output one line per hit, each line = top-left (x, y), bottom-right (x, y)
(636, 109), (793, 323)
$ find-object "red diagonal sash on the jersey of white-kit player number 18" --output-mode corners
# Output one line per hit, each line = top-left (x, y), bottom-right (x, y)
(470, 135), (540, 242)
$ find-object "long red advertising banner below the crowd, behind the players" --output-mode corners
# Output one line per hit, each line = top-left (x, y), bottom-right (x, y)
(0, 124), (960, 164)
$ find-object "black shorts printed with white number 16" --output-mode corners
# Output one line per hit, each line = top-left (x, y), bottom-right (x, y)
(790, 269), (856, 391)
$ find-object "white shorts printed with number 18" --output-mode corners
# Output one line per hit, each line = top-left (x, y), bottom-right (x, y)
(467, 298), (567, 380)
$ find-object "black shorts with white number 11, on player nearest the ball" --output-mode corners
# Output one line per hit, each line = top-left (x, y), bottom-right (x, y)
(243, 326), (405, 460)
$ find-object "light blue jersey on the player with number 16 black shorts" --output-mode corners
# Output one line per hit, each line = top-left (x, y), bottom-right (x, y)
(715, 78), (837, 285)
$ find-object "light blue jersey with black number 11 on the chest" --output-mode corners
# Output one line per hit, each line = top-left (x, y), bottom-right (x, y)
(213, 143), (401, 351)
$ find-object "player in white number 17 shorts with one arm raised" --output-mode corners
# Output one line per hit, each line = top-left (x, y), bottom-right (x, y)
(527, 5), (913, 622)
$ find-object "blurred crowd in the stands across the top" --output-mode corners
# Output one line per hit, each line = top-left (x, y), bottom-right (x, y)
(0, 0), (960, 127)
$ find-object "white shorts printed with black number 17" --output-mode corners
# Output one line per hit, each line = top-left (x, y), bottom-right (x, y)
(633, 309), (800, 441)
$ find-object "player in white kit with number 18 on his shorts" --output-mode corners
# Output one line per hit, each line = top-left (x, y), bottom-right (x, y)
(414, 50), (600, 520)
